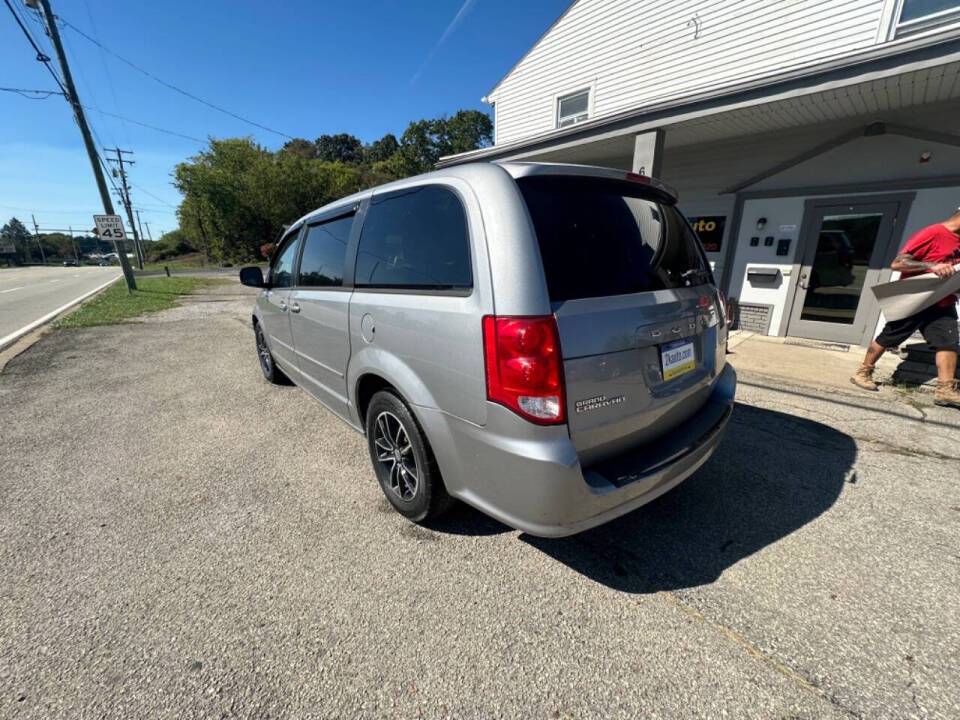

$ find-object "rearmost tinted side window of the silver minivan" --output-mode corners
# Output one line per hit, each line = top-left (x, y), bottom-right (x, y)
(356, 186), (473, 290)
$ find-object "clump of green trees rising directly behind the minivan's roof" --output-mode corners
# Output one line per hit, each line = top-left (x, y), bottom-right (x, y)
(173, 110), (493, 262)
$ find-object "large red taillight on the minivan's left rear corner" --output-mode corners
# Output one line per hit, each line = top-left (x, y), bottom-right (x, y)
(483, 315), (566, 425)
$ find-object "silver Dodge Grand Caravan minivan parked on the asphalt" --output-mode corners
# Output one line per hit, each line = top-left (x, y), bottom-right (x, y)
(240, 162), (736, 536)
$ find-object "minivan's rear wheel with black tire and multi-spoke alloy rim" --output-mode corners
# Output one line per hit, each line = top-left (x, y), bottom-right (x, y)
(366, 390), (452, 522)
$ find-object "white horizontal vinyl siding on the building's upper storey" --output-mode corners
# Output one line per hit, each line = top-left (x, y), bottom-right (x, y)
(490, 0), (890, 144)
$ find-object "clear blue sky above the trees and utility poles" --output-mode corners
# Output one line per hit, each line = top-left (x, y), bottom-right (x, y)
(0, 0), (570, 238)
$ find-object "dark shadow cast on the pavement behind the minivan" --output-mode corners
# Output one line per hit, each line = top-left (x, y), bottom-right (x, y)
(521, 404), (857, 593)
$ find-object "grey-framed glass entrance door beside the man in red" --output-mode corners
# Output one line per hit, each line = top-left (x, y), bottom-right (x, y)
(787, 202), (900, 344)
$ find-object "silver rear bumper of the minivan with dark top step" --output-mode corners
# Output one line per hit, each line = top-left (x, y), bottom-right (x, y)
(416, 365), (736, 537)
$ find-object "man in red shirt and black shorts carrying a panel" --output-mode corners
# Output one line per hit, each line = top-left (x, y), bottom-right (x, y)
(850, 209), (960, 408)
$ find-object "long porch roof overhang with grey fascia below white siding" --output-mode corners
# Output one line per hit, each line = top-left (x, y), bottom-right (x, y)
(437, 30), (960, 167)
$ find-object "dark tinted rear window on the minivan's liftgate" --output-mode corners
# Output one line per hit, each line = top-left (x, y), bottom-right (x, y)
(517, 176), (713, 302)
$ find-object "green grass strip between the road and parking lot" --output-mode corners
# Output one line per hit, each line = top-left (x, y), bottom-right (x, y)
(54, 277), (223, 328)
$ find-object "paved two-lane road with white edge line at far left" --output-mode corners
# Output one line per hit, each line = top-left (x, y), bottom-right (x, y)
(0, 266), (120, 338)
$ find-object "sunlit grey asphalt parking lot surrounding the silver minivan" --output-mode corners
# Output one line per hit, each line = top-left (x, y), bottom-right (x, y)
(0, 286), (960, 718)
